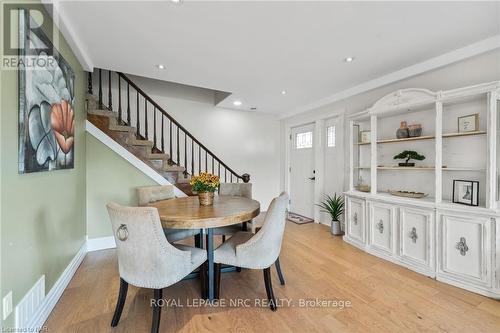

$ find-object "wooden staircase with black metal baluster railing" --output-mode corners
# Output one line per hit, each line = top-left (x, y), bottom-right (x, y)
(87, 69), (250, 195)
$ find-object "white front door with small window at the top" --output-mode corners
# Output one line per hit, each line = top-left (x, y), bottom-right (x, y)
(290, 124), (315, 218)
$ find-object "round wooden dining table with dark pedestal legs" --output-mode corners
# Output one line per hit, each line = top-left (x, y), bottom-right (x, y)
(149, 195), (260, 301)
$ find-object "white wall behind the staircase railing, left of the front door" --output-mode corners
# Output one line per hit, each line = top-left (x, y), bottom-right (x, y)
(93, 72), (280, 210)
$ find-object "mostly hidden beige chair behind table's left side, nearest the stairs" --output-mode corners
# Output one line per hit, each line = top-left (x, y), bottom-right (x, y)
(137, 185), (201, 247)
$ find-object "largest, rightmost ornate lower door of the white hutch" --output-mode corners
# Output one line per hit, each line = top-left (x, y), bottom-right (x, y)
(438, 214), (492, 287)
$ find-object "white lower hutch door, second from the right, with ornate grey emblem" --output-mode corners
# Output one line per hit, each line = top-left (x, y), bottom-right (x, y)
(400, 208), (432, 267)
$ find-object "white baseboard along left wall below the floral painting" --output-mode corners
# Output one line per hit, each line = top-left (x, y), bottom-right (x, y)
(16, 244), (87, 332)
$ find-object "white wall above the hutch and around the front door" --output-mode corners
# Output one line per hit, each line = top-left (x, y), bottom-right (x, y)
(280, 50), (500, 222)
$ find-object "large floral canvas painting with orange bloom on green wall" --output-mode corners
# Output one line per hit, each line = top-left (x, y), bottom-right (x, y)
(19, 11), (75, 173)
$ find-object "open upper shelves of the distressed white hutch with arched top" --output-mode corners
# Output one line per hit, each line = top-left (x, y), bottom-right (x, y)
(350, 82), (500, 209)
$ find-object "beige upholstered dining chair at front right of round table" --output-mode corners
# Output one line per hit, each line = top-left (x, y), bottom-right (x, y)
(214, 193), (288, 311)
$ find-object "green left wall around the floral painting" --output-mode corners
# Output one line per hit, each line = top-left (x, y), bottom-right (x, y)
(0, 1), (86, 327)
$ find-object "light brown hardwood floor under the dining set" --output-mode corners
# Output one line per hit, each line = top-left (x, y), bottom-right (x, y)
(45, 223), (500, 333)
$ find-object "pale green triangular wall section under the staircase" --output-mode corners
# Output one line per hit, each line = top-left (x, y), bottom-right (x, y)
(86, 132), (158, 239)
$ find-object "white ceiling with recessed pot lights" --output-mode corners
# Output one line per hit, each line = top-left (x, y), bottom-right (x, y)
(55, 0), (500, 115)
